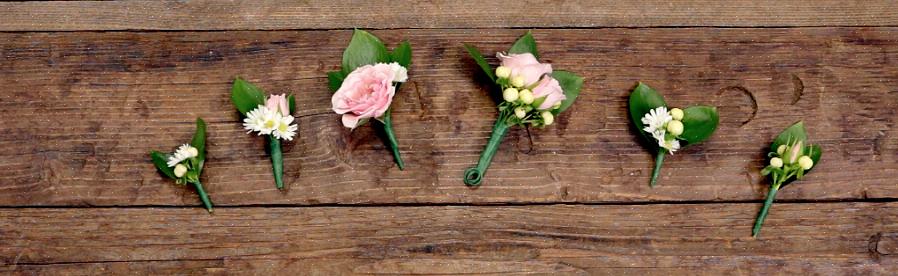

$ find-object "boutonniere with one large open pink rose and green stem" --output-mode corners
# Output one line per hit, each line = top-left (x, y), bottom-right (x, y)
(327, 30), (412, 170)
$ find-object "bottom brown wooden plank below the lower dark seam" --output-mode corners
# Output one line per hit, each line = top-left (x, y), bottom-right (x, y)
(0, 203), (898, 275)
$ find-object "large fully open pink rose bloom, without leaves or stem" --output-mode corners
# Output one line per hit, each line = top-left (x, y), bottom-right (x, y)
(331, 63), (397, 128)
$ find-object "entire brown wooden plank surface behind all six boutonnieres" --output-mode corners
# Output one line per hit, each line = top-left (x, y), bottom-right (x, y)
(0, 0), (898, 275)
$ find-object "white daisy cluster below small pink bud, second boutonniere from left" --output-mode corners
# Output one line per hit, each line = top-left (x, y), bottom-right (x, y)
(243, 105), (298, 141)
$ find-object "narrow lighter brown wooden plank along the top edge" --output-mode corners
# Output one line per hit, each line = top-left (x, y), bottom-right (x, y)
(0, 0), (898, 31)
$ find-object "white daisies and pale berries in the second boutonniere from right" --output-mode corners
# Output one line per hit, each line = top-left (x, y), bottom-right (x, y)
(642, 106), (683, 154)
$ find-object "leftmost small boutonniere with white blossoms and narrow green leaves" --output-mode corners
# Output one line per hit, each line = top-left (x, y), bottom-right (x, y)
(150, 118), (212, 213)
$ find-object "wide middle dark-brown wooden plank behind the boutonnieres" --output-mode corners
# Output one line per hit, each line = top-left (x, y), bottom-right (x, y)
(0, 28), (898, 206)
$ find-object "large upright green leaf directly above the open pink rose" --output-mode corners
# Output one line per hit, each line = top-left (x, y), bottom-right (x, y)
(343, 29), (390, 73)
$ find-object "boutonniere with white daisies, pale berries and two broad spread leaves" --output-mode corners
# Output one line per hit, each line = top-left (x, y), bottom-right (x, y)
(630, 82), (719, 187)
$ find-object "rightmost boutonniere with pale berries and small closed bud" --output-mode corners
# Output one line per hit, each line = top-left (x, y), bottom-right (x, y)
(751, 122), (823, 237)
